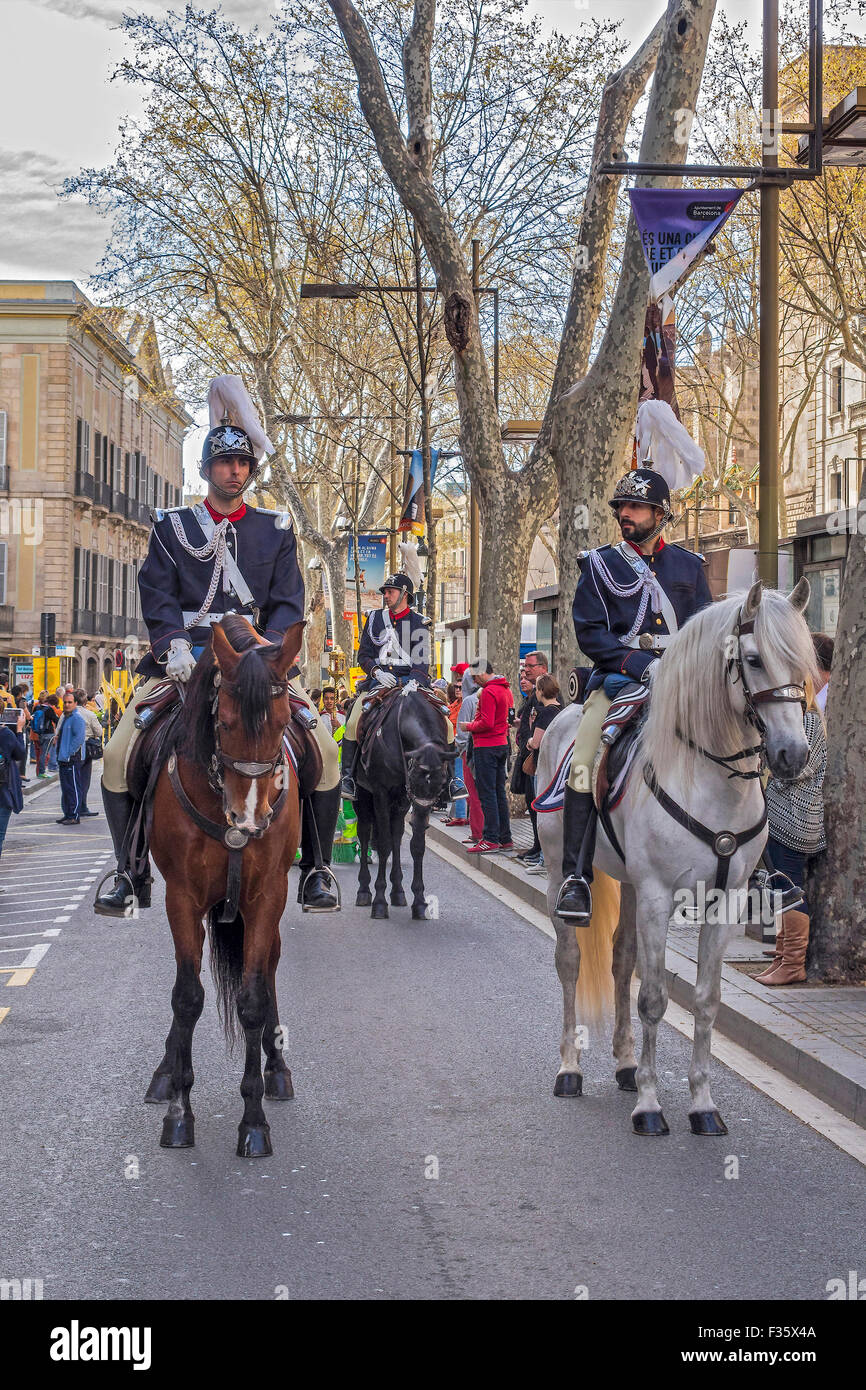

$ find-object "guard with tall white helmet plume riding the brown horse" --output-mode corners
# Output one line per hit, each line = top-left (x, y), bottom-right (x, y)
(95, 377), (339, 917)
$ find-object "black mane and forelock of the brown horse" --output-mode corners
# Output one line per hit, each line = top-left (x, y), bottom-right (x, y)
(182, 625), (279, 767)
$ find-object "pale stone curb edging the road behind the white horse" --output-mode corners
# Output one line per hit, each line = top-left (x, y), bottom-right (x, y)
(427, 823), (866, 1129)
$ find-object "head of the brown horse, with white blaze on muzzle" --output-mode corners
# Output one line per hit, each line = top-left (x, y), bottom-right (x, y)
(211, 614), (304, 835)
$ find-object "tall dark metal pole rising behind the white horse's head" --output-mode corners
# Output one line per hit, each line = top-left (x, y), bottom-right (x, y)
(758, 0), (780, 588)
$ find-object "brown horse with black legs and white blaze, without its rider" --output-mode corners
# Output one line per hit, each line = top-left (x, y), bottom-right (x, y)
(145, 614), (304, 1158)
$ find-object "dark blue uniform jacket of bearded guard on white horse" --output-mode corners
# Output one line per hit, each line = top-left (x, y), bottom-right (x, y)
(571, 545), (713, 694)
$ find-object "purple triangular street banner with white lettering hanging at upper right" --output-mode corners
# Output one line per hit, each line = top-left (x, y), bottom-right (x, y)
(628, 188), (742, 300)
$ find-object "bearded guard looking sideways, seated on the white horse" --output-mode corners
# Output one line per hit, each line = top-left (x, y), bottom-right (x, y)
(556, 467), (712, 926)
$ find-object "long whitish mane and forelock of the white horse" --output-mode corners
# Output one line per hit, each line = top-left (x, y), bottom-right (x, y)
(641, 589), (817, 785)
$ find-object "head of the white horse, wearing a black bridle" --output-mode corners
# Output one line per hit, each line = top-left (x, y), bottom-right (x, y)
(728, 575), (816, 778)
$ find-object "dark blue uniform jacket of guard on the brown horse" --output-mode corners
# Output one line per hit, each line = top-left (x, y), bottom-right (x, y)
(138, 506), (304, 677)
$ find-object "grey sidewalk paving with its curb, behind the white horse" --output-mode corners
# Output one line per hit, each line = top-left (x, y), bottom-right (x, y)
(428, 817), (866, 1129)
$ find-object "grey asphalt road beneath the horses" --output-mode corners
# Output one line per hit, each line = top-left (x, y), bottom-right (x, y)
(0, 788), (866, 1300)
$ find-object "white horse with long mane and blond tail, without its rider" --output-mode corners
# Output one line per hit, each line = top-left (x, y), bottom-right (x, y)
(537, 578), (816, 1134)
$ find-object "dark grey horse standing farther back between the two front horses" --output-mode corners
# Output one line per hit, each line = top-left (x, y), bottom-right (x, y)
(354, 685), (456, 922)
